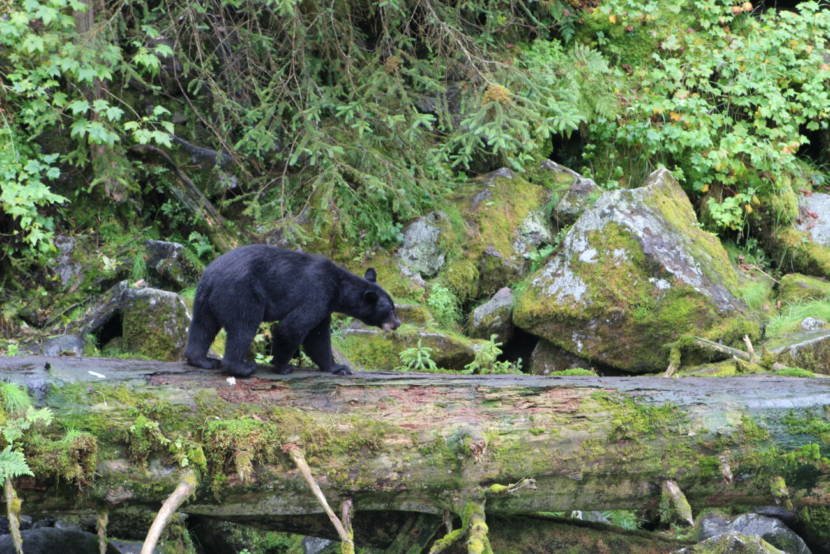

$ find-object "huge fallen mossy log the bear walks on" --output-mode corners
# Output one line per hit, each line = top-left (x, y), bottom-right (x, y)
(0, 357), (830, 538)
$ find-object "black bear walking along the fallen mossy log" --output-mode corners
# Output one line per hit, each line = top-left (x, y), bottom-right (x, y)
(185, 244), (400, 377)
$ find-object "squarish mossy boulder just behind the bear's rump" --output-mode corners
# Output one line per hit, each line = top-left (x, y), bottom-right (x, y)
(121, 287), (190, 361)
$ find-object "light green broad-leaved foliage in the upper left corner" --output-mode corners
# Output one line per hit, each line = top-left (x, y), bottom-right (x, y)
(0, 0), (172, 258)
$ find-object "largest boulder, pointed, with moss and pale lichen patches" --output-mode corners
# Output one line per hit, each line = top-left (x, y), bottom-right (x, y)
(513, 169), (760, 373)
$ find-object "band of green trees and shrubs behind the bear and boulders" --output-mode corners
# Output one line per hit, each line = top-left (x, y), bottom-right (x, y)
(0, 0), (830, 326)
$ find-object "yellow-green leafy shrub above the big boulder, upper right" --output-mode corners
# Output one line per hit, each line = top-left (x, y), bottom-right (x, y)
(589, 0), (830, 230)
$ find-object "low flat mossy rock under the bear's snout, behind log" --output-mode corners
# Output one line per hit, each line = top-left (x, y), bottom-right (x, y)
(333, 325), (477, 371)
